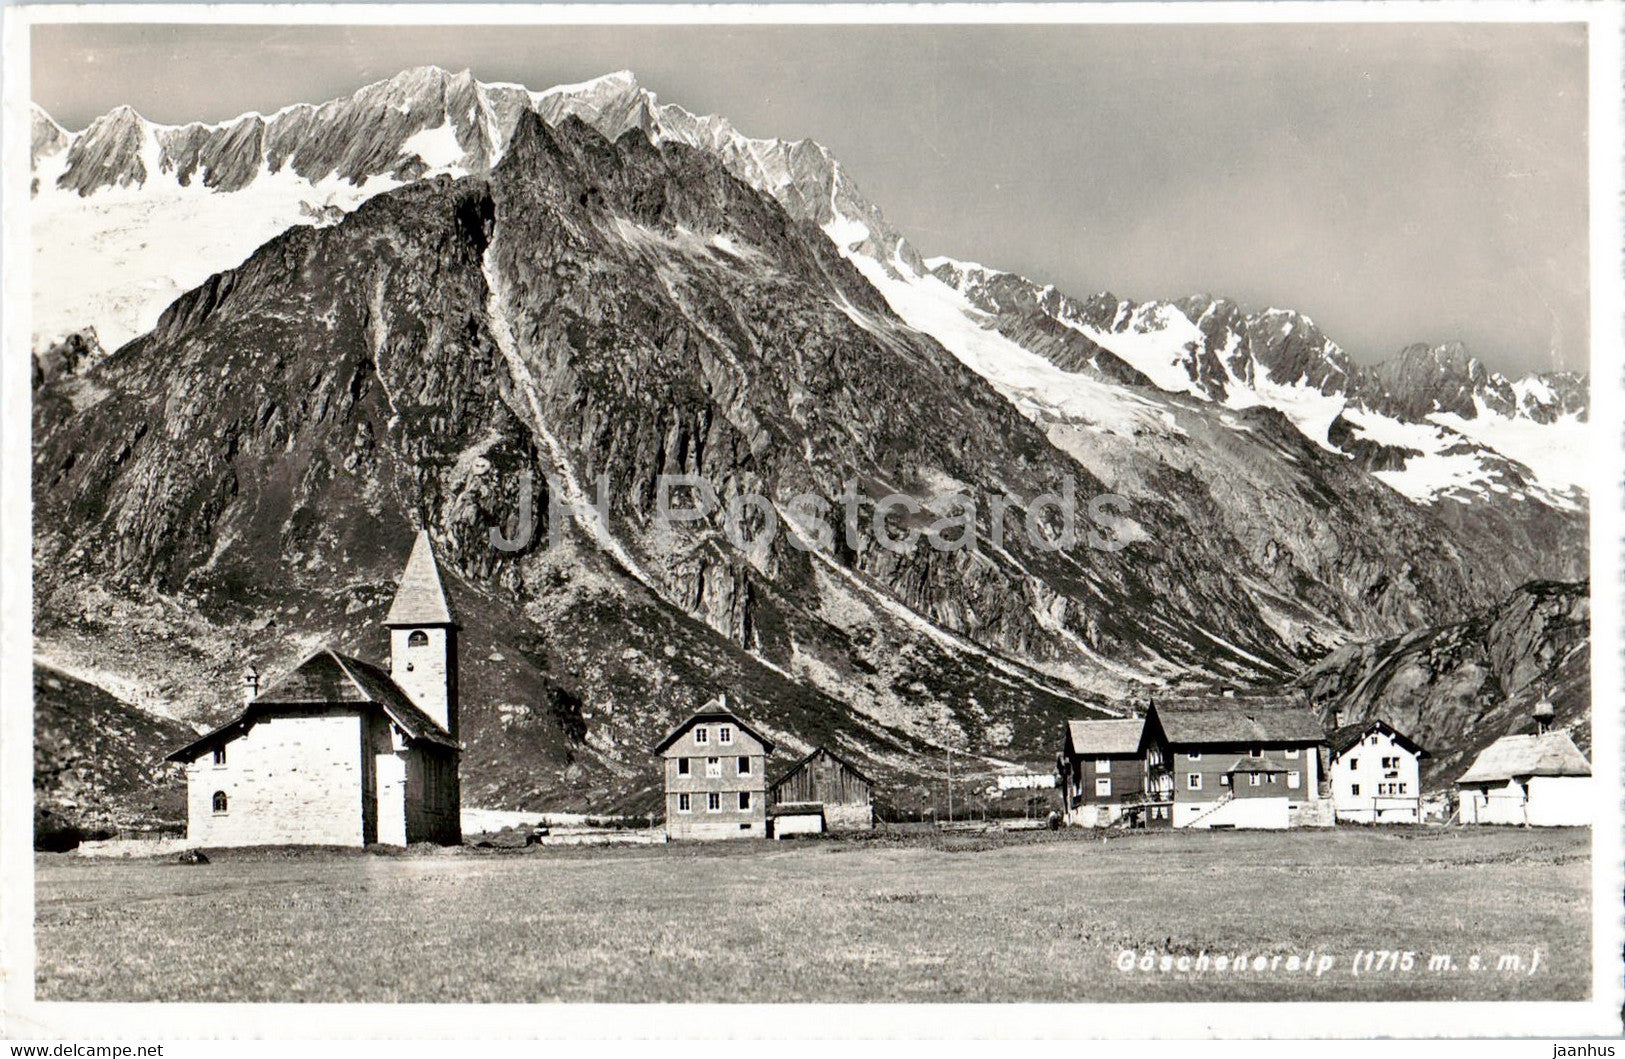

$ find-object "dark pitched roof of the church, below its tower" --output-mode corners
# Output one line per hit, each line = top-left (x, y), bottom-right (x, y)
(166, 646), (458, 762)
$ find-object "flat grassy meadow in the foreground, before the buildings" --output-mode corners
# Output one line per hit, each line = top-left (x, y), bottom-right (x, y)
(36, 828), (1591, 1002)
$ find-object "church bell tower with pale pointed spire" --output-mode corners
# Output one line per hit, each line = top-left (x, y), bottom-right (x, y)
(384, 530), (462, 739)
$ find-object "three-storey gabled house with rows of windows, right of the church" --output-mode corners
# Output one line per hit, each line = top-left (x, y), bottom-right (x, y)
(653, 695), (774, 840)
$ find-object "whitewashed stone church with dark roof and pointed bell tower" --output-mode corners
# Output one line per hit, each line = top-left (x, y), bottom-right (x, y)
(169, 533), (462, 846)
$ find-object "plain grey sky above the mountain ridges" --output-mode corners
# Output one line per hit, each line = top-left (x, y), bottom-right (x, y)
(33, 24), (1589, 372)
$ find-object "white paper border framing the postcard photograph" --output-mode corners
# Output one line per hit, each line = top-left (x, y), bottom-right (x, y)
(0, 0), (1625, 1039)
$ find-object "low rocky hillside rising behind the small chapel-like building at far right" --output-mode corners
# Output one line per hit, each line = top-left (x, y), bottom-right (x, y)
(1298, 581), (1591, 788)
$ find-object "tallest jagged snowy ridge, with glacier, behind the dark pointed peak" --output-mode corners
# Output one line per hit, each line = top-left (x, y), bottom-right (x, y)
(33, 67), (925, 349)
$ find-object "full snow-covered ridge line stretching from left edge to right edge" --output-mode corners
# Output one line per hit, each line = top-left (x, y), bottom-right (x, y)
(31, 67), (1586, 516)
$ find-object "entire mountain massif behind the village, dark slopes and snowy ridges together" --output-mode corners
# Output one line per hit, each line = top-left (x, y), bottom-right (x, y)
(34, 70), (1584, 809)
